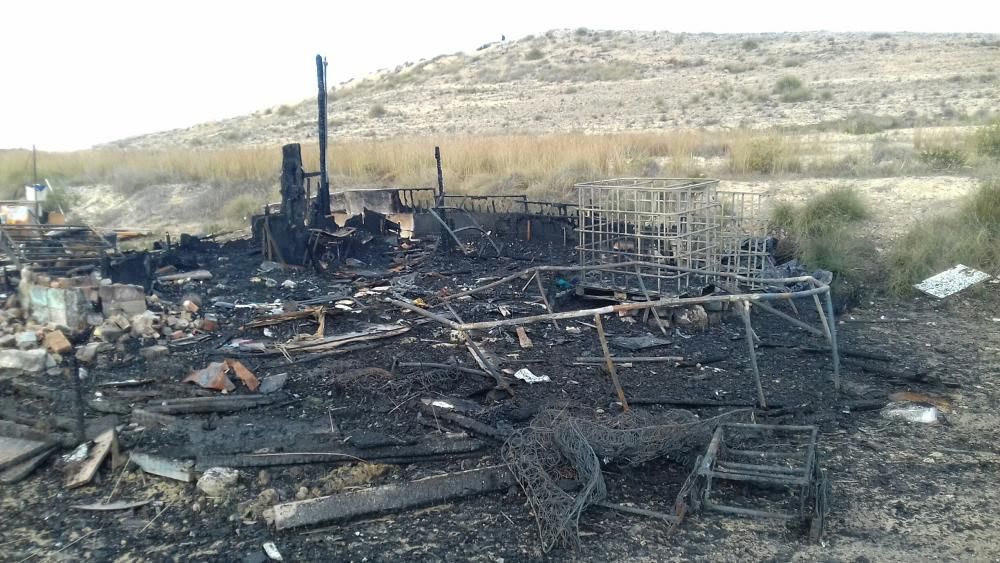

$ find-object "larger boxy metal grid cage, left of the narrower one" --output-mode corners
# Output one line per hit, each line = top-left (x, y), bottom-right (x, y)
(576, 178), (722, 295)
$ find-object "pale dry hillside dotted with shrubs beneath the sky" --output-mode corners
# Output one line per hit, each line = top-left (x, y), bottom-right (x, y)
(108, 29), (1000, 148)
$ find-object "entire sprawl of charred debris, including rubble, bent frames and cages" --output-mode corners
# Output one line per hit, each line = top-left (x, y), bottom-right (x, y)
(7, 171), (924, 551)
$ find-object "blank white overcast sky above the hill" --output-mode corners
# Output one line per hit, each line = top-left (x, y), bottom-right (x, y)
(0, 0), (1000, 150)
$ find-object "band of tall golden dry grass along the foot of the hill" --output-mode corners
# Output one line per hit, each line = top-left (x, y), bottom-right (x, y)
(0, 130), (824, 205)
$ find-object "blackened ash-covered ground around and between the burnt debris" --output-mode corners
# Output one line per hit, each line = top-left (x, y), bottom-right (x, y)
(0, 236), (1000, 561)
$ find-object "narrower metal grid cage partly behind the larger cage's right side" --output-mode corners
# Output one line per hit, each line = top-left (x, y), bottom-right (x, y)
(717, 190), (773, 290)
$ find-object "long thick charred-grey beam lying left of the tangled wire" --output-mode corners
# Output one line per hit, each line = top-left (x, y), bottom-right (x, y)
(272, 467), (514, 530)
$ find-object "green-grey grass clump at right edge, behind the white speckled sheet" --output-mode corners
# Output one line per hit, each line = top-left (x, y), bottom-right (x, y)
(889, 179), (1000, 295)
